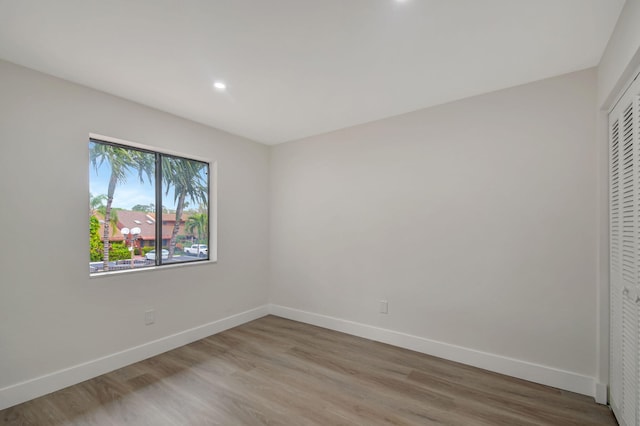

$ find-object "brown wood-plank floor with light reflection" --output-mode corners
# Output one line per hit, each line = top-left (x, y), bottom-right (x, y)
(0, 316), (616, 426)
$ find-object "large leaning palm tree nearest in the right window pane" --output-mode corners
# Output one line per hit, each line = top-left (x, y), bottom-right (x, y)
(162, 156), (208, 259)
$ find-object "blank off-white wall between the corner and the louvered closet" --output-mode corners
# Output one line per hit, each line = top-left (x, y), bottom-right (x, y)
(270, 69), (597, 393)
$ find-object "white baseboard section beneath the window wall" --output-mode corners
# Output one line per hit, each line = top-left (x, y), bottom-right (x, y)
(0, 305), (269, 410)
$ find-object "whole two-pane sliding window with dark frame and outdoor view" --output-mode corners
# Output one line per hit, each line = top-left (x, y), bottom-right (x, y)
(89, 138), (215, 274)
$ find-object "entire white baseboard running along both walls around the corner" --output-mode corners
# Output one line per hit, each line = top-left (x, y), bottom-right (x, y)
(0, 304), (607, 410)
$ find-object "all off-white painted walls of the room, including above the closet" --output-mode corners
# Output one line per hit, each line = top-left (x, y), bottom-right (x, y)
(0, 24), (640, 407)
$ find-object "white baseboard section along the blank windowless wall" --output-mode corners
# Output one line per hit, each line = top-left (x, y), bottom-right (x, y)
(269, 304), (606, 403)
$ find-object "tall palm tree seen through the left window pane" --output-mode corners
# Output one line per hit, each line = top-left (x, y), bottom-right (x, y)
(89, 141), (153, 271)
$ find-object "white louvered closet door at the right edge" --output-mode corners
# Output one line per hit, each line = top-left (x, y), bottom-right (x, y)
(609, 73), (640, 426)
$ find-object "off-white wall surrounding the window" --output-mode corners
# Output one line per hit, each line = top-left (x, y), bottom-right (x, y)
(0, 61), (269, 408)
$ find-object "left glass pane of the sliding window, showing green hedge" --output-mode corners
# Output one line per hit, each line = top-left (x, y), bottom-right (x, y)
(89, 140), (156, 273)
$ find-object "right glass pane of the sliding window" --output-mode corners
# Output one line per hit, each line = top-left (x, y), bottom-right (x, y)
(161, 155), (209, 263)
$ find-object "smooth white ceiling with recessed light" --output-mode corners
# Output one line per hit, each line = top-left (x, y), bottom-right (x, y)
(0, 0), (624, 144)
